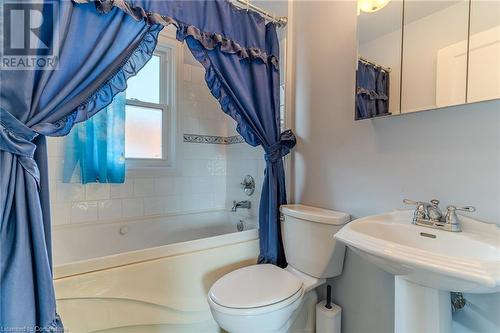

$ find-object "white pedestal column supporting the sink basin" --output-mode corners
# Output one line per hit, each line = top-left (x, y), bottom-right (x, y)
(394, 276), (451, 333)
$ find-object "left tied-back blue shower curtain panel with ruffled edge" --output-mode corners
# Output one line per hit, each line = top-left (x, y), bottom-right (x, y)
(0, 1), (163, 332)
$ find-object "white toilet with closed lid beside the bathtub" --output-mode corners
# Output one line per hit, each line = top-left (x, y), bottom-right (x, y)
(208, 205), (350, 333)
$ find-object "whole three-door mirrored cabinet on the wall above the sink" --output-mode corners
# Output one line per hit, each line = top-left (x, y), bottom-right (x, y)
(356, 0), (500, 120)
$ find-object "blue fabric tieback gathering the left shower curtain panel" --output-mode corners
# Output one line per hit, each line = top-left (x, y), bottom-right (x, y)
(0, 108), (40, 184)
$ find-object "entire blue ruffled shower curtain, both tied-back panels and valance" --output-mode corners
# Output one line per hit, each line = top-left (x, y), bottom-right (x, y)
(0, 0), (295, 332)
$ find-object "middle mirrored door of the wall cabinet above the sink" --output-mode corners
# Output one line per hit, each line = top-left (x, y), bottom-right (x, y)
(401, 0), (469, 113)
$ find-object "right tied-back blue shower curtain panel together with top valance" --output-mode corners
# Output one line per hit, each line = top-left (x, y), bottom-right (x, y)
(96, 0), (296, 267)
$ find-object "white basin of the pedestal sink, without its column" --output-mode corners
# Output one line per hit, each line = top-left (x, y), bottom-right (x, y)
(335, 211), (500, 293)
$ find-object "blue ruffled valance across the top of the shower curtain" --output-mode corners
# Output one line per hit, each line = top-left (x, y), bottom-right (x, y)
(74, 0), (279, 69)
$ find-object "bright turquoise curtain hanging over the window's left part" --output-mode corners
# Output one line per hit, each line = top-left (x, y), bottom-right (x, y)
(63, 93), (125, 184)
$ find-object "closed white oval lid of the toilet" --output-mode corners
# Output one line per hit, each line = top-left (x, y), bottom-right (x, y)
(209, 264), (302, 309)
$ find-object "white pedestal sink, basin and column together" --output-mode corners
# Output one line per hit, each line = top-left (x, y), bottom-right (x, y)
(335, 211), (500, 333)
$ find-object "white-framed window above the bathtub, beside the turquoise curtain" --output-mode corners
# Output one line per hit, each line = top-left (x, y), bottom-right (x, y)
(125, 43), (175, 168)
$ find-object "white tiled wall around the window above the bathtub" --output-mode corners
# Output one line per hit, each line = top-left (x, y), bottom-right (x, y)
(48, 57), (263, 225)
